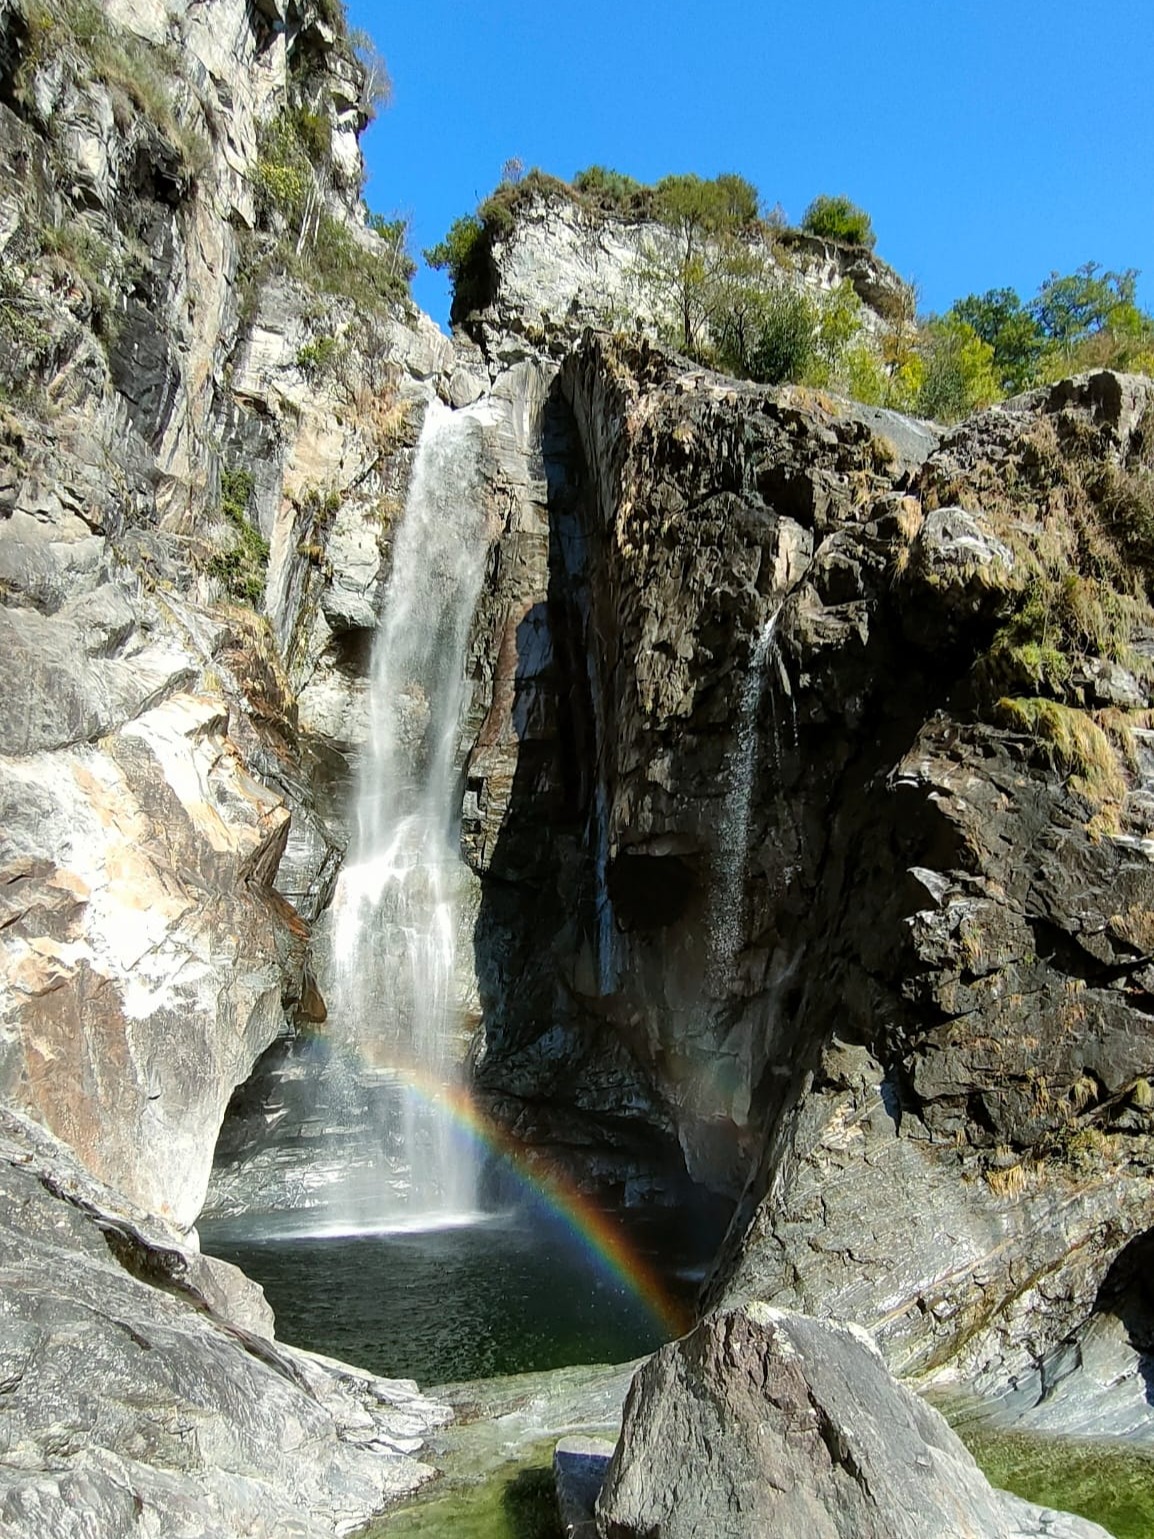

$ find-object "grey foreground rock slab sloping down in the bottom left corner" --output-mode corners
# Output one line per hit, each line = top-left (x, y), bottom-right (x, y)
(0, 1116), (449, 1539)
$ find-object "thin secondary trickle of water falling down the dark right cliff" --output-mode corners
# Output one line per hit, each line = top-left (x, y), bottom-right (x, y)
(709, 606), (797, 991)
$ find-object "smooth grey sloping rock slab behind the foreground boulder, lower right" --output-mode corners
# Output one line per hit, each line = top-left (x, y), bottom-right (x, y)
(725, 1043), (1148, 1391)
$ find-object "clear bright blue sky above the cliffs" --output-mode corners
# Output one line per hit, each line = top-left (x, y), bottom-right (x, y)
(348, 0), (1154, 325)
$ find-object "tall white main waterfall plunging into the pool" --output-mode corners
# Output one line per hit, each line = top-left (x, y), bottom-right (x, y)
(329, 402), (488, 1228)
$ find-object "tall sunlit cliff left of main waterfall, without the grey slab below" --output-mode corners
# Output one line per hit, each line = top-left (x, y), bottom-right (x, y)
(0, 0), (451, 1228)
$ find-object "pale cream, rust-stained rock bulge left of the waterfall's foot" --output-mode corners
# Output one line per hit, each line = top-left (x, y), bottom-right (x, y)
(0, 694), (294, 1227)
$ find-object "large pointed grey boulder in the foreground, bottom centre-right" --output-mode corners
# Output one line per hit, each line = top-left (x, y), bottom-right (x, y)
(597, 1304), (1106, 1539)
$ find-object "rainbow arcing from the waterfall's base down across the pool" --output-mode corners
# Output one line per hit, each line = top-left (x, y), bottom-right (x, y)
(346, 1063), (692, 1336)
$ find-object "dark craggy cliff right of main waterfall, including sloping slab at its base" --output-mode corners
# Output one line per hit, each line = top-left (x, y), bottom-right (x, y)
(465, 339), (1154, 1394)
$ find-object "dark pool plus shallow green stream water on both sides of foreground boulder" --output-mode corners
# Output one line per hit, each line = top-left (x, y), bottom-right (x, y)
(202, 1208), (1154, 1539)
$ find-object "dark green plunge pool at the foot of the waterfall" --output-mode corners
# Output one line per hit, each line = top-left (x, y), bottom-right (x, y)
(202, 1210), (700, 1385)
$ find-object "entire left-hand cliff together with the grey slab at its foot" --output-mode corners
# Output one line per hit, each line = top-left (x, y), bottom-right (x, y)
(0, 0), (461, 1534)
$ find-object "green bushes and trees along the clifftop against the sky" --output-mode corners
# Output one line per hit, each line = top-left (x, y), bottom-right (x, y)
(425, 166), (1154, 422)
